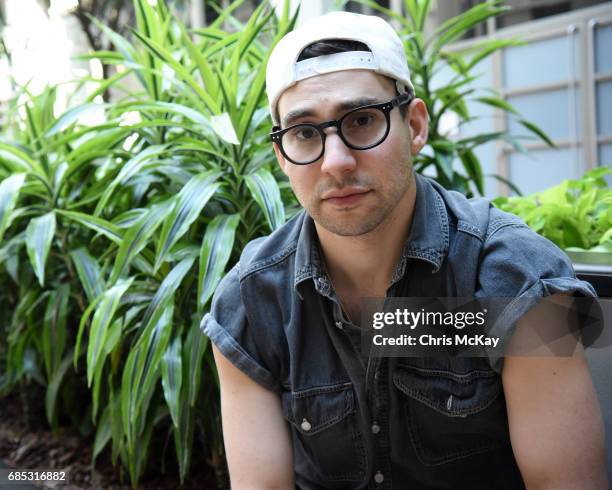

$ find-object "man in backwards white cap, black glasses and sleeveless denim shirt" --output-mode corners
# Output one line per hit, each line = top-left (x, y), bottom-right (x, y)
(203, 12), (607, 490)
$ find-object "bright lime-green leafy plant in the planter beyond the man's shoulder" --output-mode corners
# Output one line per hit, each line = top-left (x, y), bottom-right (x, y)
(493, 167), (612, 253)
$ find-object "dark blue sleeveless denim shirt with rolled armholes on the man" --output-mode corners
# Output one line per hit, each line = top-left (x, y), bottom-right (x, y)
(202, 175), (595, 490)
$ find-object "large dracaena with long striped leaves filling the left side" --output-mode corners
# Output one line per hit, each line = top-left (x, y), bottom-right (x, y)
(0, 0), (296, 485)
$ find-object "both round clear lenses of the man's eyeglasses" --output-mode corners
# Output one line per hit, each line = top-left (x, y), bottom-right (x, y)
(282, 108), (387, 163)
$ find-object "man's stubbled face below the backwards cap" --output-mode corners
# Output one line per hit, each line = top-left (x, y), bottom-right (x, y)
(274, 70), (426, 236)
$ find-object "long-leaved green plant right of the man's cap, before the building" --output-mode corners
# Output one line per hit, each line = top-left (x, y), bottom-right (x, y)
(350, 0), (554, 196)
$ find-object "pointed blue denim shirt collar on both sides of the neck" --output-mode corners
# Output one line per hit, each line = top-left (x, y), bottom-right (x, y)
(294, 174), (449, 298)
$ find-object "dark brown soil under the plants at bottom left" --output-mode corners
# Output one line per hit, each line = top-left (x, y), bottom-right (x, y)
(0, 395), (217, 490)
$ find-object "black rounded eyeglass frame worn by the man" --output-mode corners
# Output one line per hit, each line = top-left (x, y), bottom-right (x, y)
(270, 92), (415, 165)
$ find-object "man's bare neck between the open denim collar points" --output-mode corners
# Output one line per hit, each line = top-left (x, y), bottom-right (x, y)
(315, 176), (416, 297)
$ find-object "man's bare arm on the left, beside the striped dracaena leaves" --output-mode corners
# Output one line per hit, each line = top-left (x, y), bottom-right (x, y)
(213, 345), (295, 490)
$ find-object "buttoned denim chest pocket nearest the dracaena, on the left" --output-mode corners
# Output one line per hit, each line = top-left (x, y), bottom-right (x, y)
(281, 383), (366, 486)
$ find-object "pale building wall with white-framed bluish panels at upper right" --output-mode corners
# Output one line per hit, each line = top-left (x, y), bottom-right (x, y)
(444, 2), (612, 195)
